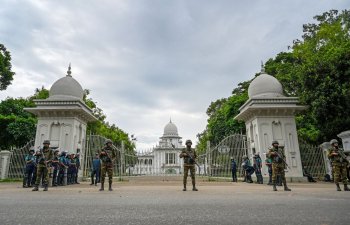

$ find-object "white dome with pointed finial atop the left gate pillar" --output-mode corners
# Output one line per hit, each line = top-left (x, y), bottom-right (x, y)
(48, 65), (84, 100)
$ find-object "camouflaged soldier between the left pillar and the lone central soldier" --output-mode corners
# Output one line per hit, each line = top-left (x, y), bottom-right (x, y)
(99, 139), (117, 191)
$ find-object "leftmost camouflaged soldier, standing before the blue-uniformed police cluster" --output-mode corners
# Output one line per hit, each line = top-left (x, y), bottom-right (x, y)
(33, 140), (53, 191)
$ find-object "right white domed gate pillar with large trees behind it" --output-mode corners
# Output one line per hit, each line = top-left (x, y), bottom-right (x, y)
(235, 69), (306, 180)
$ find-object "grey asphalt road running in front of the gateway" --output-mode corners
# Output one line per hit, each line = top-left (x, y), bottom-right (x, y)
(0, 181), (350, 225)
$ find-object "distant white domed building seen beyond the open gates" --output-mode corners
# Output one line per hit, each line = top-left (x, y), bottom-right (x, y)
(133, 120), (185, 175)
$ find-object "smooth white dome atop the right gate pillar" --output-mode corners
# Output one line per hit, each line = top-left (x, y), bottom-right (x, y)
(248, 71), (284, 98)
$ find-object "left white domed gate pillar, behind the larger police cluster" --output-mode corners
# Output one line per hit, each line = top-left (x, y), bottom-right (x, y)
(25, 65), (96, 177)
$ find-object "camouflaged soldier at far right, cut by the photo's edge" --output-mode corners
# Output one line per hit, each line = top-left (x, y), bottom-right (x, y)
(328, 139), (350, 191)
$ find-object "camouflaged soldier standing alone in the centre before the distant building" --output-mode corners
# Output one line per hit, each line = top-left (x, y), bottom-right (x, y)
(180, 140), (198, 191)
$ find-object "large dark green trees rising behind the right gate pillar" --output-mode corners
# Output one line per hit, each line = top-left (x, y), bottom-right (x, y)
(198, 10), (350, 151)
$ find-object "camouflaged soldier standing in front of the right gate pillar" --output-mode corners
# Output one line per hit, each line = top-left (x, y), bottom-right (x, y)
(267, 141), (291, 191)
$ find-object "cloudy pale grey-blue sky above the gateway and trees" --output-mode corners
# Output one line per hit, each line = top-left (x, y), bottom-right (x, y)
(0, 0), (350, 151)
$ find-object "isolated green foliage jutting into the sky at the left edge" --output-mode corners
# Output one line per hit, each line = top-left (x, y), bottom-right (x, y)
(0, 44), (15, 90)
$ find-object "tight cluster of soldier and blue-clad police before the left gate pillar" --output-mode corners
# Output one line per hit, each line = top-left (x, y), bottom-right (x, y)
(23, 140), (80, 191)
